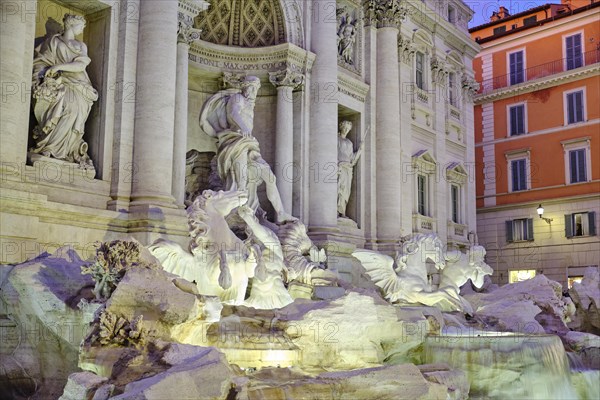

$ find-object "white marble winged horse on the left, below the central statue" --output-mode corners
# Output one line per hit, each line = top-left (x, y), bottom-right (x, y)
(149, 190), (257, 305)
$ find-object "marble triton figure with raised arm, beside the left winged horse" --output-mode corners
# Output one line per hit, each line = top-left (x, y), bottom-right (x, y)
(237, 205), (294, 310)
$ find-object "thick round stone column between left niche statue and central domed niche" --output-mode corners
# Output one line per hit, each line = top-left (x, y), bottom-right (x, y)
(131, 1), (178, 207)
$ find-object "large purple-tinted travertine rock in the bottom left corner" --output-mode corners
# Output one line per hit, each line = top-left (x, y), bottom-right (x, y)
(0, 247), (97, 398)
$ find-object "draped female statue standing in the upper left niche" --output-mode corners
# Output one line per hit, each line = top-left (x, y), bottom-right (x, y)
(31, 14), (98, 169)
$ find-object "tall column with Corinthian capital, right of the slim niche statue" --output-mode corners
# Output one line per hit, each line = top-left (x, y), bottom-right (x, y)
(376, 0), (405, 251)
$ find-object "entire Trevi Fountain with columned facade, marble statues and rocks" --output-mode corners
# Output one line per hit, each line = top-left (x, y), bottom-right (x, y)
(0, 0), (600, 400)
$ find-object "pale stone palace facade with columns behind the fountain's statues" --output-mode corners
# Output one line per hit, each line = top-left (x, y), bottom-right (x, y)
(0, 0), (479, 277)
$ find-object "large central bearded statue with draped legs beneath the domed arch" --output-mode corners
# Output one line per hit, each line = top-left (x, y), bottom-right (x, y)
(200, 76), (294, 223)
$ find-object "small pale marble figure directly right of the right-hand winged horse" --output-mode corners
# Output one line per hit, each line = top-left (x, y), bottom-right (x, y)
(438, 245), (494, 315)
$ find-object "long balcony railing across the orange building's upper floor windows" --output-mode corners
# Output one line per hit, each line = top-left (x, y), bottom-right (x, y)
(479, 49), (600, 94)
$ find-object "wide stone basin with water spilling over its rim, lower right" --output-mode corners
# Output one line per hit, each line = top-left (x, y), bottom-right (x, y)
(424, 330), (600, 400)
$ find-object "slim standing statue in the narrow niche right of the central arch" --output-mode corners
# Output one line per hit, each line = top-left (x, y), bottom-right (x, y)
(337, 121), (365, 217)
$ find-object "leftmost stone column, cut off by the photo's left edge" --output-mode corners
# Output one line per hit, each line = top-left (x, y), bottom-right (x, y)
(0, 1), (37, 164)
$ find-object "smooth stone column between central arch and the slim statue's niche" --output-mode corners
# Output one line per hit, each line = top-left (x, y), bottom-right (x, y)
(305, 0), (338, 236)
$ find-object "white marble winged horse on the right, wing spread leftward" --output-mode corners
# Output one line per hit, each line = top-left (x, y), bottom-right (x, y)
(352, 234), (463, 311)
